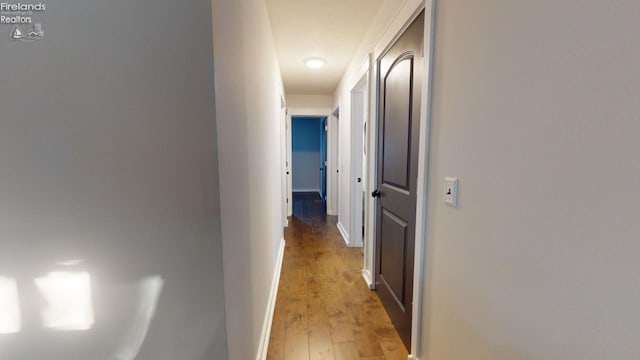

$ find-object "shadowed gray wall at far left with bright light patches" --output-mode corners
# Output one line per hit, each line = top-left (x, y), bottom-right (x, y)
(0, 0), (226, 360)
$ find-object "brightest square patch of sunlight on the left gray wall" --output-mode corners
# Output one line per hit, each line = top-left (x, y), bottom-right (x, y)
(35, 272), (94, 331)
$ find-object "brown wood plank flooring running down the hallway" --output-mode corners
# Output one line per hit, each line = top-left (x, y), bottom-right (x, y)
(267, 194), (408, 360)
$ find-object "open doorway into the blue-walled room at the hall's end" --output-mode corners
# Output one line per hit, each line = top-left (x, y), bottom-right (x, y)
(291, 116), (327, 215)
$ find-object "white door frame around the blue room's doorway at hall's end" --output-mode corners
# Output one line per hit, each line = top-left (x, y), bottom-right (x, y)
(285, 108), (334, 216)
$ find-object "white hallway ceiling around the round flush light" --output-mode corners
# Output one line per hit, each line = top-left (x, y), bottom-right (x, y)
(266, 0), (382, 94)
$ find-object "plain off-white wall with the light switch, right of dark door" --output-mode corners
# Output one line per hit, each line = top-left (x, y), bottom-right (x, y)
(422, 0), (640, 360)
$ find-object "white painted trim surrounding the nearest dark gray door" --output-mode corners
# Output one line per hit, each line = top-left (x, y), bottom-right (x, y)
(370, 0), (435, 359)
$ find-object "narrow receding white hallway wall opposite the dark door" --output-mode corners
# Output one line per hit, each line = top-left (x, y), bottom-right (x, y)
(213, 0), (283, 359)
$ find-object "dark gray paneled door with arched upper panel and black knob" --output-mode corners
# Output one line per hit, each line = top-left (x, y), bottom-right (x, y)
(372, 12), (424, 350)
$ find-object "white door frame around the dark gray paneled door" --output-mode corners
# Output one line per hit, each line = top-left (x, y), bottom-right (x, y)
(363, 0), (436, 359)
